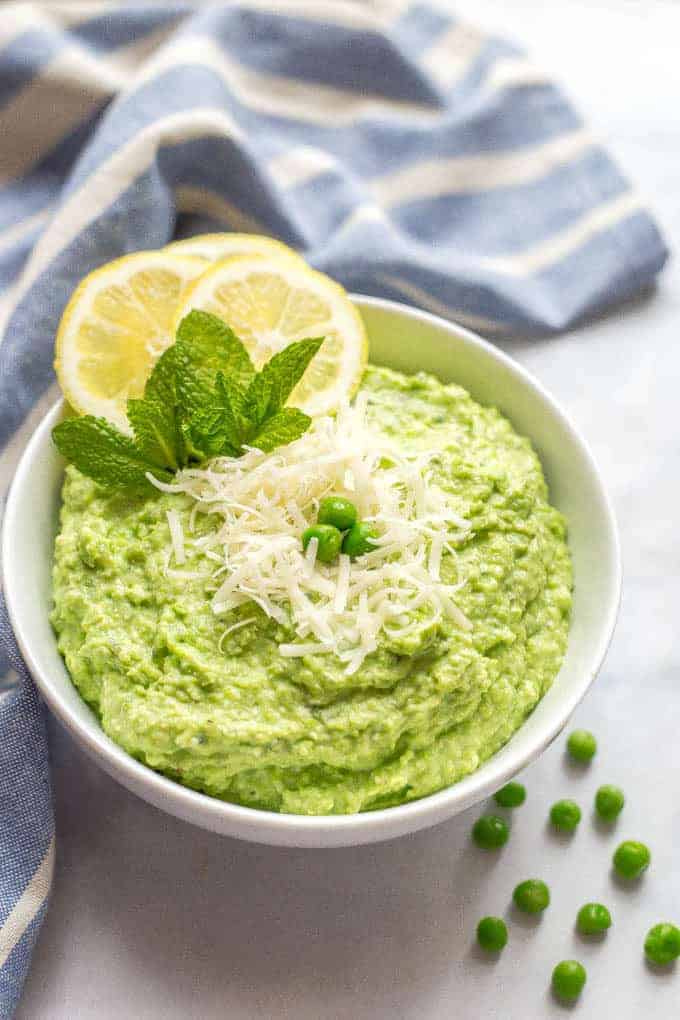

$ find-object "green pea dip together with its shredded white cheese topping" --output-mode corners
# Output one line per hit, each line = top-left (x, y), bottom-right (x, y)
(52, 366), (571, 814)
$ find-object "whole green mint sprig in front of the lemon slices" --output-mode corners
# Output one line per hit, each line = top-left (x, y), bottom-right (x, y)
(52, 311), (323, 493)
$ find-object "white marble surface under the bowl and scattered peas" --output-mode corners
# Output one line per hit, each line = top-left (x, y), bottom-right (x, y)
(17, 0), (680, 1020)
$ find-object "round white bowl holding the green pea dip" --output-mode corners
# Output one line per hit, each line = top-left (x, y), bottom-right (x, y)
(2, 296), (621, 847)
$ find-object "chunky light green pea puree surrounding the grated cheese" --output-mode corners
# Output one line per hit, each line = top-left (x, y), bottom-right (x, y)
(52, 367), (571, 814)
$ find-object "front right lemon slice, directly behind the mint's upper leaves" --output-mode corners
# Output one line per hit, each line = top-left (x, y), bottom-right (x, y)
(176, 255), (368, 415)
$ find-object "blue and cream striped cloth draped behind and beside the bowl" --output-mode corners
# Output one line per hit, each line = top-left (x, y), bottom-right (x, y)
(0, 0), (667, 1017)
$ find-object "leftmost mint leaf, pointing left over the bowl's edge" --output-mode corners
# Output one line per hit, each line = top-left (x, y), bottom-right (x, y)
(52, 414), (172, 493)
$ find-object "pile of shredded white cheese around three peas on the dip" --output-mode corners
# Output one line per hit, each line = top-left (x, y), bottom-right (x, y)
(150, 394), (471, 674)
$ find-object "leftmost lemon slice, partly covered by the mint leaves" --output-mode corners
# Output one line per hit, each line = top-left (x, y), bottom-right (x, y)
(54, 251), (205, 431)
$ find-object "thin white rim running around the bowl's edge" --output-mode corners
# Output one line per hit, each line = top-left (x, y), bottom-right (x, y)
(1, 294), (622, 847)
